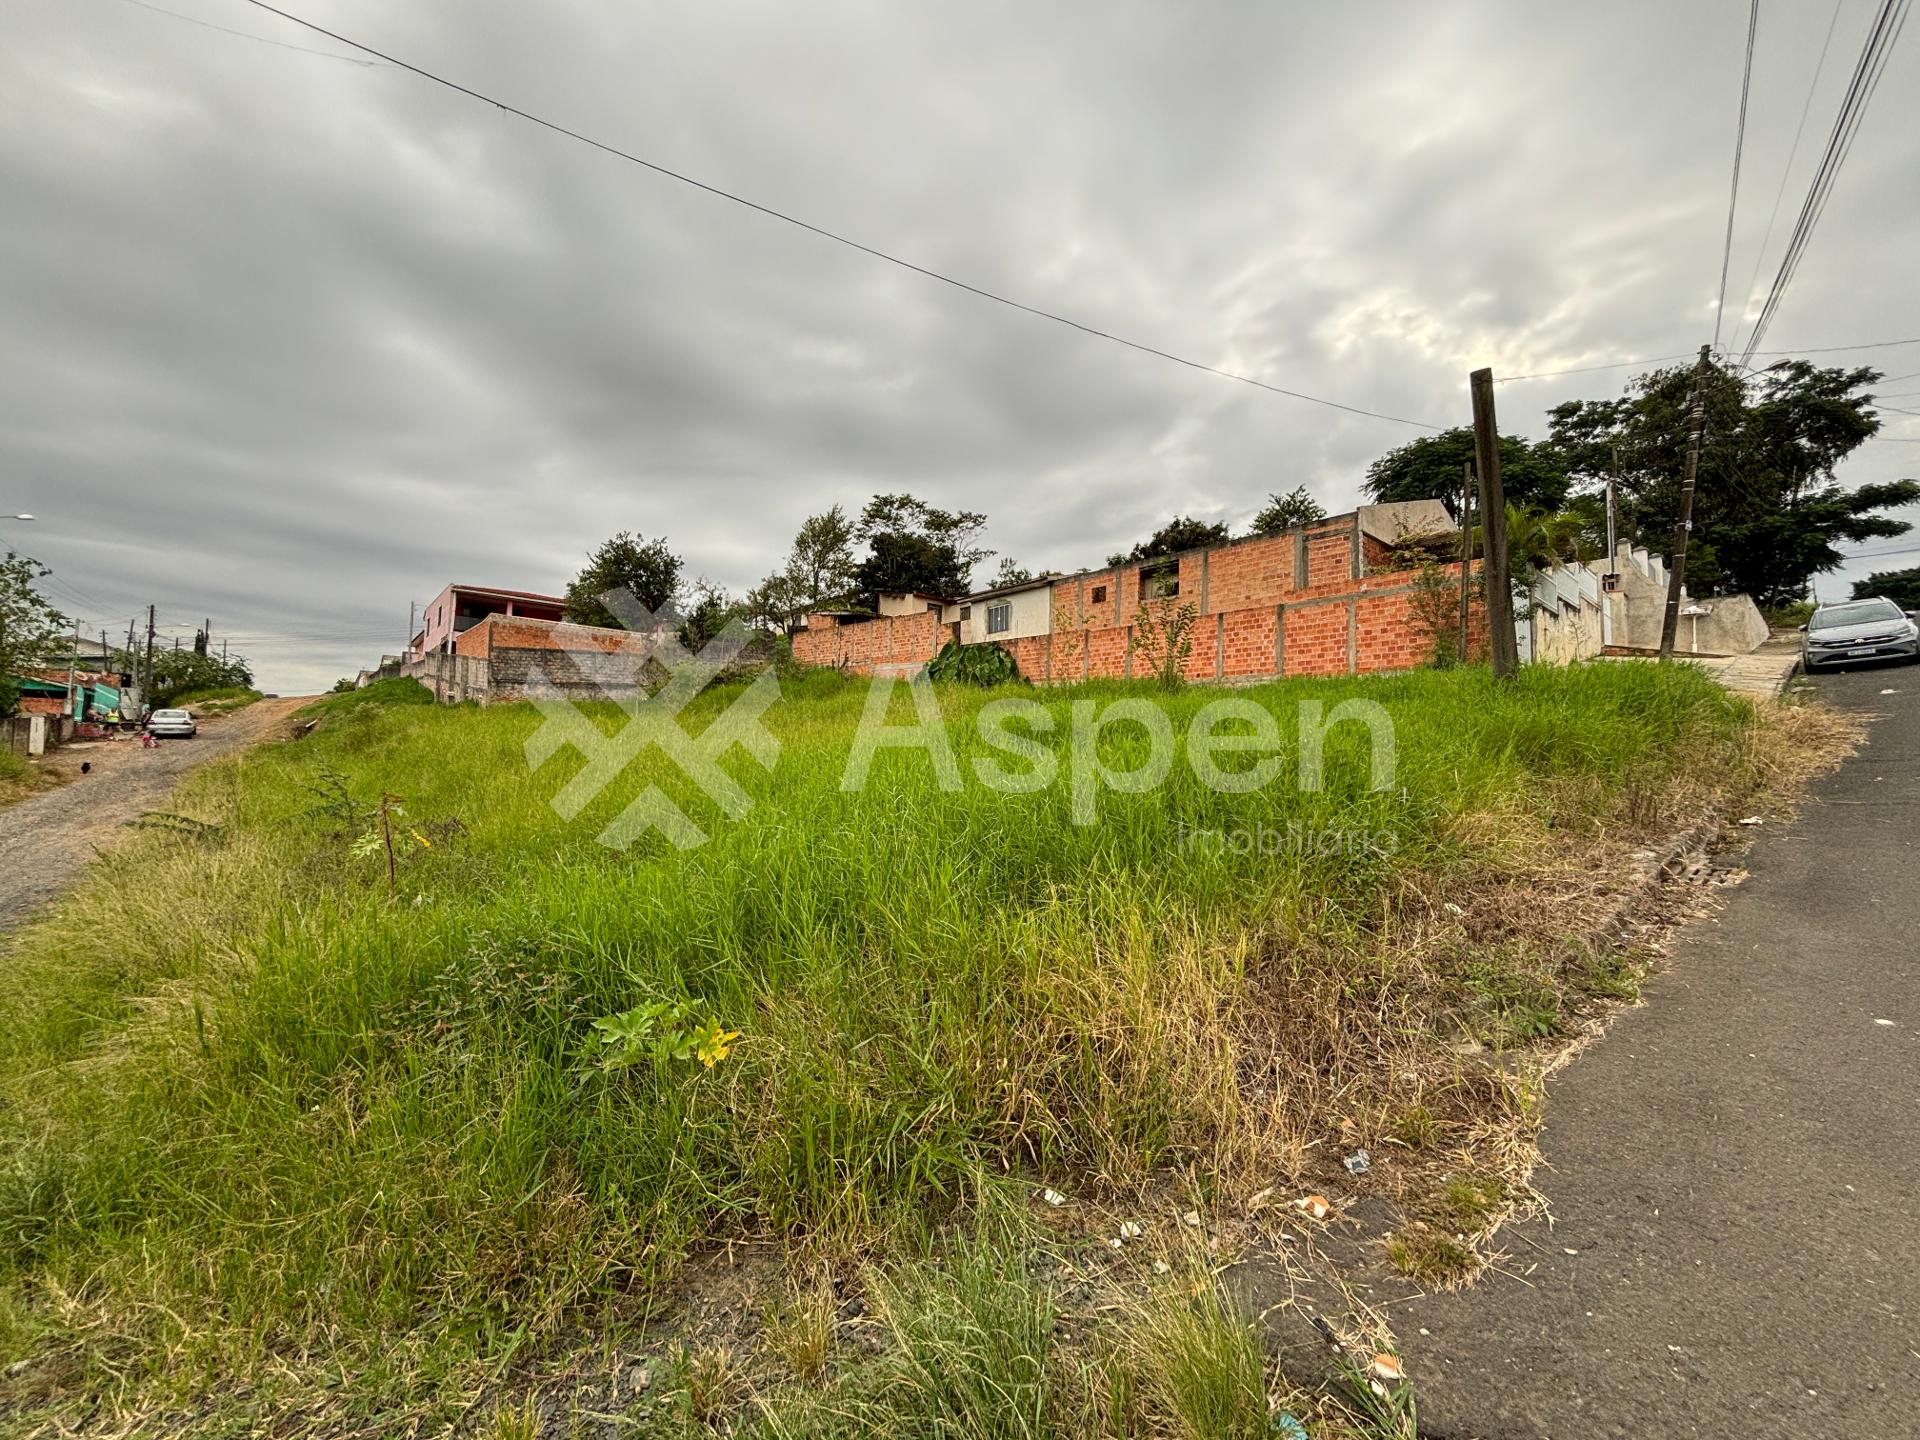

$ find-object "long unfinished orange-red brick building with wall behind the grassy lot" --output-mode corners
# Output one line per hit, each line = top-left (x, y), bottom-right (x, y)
(793, 501), (1484, 684)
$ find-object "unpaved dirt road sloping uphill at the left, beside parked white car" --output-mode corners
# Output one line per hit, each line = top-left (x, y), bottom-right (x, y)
(0, 695), (313, 933)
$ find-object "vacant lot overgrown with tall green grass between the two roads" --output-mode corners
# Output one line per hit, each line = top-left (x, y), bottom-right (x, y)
(0, 664), (1755, 1434)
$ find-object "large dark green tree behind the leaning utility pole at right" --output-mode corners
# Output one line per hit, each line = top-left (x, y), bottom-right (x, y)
(1548, 361), (1920, 609)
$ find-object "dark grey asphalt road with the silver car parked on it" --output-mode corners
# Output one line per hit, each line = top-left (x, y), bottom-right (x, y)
(1392, 666), (1920, 1440)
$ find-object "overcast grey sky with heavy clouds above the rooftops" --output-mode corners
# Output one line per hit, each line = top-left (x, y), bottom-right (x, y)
(0, 0), (1920, 693)
